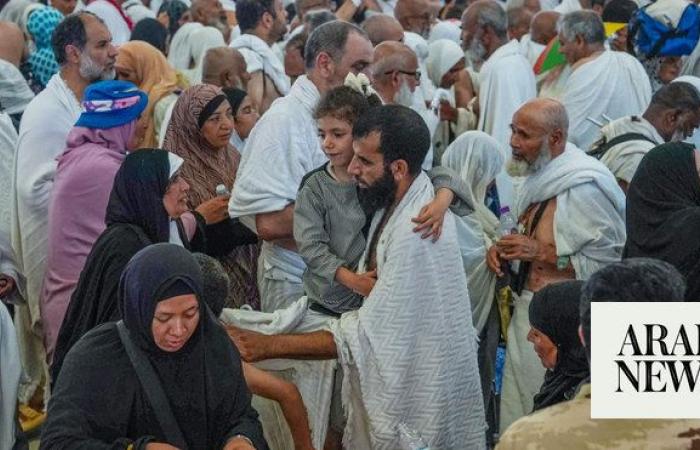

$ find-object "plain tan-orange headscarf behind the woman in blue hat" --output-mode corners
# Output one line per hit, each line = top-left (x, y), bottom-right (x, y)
(116, 41), (186, 148)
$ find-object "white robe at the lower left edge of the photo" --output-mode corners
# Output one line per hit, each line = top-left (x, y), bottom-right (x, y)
(0, 305), (22, 450)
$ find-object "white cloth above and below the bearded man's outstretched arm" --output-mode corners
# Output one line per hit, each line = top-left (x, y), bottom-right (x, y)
(219, 297), (337, 450)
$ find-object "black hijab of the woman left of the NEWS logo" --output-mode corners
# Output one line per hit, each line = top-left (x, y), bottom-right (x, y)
(529, 281), (589, 411)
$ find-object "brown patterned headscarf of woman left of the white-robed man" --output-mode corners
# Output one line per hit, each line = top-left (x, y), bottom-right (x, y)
(163, 84), (241, 209)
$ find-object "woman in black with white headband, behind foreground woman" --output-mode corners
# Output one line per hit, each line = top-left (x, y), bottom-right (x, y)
(51, 149), (235, 382)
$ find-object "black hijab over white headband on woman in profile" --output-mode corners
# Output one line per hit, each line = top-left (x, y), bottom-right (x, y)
(105, 149), (178, 243)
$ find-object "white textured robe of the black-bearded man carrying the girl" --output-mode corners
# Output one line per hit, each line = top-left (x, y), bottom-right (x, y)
(329, 173), (485, 449)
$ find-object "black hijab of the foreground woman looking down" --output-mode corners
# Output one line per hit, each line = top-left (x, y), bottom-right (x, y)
(119, 244), (239, 449)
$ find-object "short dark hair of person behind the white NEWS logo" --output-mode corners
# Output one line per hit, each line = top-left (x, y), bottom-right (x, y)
(579, 258), (686, 357)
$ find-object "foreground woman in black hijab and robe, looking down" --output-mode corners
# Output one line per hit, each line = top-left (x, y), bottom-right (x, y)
(41, 243), (268, 450)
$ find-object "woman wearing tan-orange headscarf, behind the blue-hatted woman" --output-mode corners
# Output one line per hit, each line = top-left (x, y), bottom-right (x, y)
(115, 41), (188, 148)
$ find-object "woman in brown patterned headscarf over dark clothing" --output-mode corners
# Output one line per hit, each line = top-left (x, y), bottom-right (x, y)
(163, 84), (259, 307)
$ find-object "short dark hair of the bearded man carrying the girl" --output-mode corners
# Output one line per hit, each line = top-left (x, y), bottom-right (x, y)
(352, 105), (430, 175)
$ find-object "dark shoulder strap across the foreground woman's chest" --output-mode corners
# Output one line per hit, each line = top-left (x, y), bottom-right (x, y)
(117, 320), (187, 450)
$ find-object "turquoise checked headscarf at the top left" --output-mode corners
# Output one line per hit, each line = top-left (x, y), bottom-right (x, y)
(27, 6), (63, 86)
